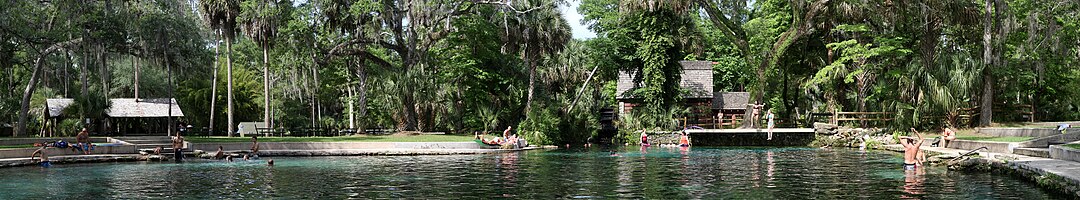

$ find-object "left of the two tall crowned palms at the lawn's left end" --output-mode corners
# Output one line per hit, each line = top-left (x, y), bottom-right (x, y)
(200, 0), (240, 137)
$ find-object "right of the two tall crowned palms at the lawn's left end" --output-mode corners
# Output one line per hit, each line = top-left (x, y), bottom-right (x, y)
(240, 0), (292, 129)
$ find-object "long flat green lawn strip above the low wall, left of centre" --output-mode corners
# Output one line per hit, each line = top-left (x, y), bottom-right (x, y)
(185, 135), (473, 143)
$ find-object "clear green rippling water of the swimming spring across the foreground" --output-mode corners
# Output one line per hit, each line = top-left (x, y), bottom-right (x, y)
(0, 147), (1063, 199)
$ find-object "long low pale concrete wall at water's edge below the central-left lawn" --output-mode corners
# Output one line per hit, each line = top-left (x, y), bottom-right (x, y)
(188, 142), (489, 151)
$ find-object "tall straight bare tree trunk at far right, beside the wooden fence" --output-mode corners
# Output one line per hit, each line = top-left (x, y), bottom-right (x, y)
(978, 0), (995, 126)
